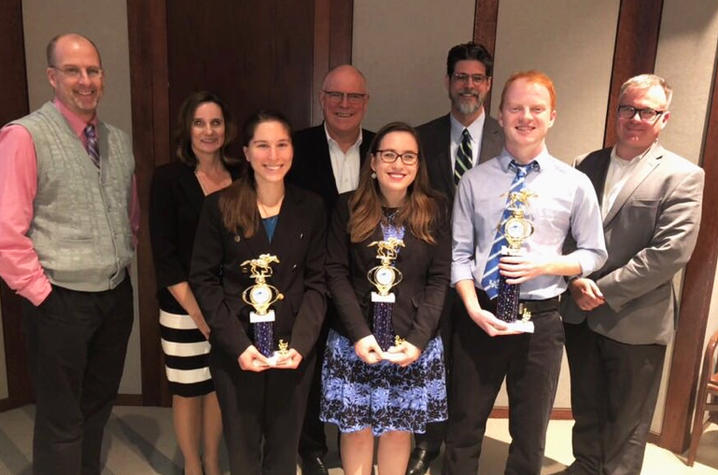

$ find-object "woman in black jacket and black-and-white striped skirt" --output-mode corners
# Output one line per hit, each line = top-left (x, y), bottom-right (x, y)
(150, 91), (237, 475)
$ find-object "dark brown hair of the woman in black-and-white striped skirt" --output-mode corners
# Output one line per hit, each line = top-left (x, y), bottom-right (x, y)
(174, 91), (238, 167)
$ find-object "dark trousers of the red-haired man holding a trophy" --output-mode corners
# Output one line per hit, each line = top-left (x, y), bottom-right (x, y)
(443, 301), (564, 475)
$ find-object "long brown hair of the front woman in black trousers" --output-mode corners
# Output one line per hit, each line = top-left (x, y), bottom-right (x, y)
(219, 110), (292, 239)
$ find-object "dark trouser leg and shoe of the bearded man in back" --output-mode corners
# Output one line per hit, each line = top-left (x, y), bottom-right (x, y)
(414, 288), (458, 453)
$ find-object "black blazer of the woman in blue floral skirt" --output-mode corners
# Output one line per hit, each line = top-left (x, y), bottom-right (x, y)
(326, 193), (451, 349)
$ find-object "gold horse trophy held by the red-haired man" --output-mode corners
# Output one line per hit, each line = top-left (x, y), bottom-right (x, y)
(496, 189), (536, 333)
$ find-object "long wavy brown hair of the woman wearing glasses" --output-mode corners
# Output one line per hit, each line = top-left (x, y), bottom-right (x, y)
(347, 122), (441, 244)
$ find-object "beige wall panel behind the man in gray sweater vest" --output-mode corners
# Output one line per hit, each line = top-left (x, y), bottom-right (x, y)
(20, 0), (142, 394)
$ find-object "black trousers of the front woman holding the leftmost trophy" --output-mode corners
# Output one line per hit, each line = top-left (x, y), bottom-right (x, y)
(210, 349), (316, 475)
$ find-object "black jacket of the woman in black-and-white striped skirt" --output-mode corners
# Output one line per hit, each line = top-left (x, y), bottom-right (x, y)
(149, 162), (239, 314)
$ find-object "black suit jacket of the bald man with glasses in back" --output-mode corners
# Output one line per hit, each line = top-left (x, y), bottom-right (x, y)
(287, 124), (374, 213)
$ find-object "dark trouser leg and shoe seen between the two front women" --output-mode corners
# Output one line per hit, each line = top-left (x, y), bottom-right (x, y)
(299, 321), (329, 459)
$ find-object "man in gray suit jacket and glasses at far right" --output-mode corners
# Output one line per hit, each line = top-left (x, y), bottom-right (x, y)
(562, 74), (704, 474)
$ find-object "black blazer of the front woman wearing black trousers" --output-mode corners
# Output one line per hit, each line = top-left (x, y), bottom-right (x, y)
(189, 185), (326, 360)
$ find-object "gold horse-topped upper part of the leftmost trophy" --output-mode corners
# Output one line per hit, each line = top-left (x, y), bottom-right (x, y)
(241, 254), (284, 323)
